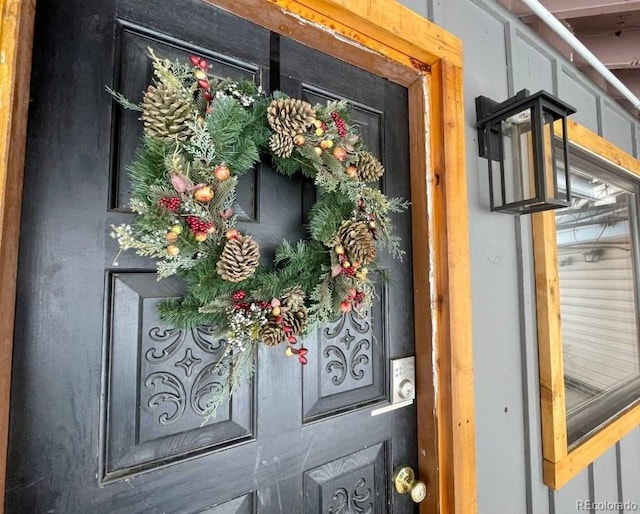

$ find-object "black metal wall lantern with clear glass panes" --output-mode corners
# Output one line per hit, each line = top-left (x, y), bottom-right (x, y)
(476, 89), (576, 214)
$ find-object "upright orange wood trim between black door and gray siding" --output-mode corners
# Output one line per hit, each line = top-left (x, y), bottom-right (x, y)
(430, 60), (477, 513)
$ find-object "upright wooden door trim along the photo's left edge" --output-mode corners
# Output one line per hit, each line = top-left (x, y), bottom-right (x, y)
(0, 0), (35, 508)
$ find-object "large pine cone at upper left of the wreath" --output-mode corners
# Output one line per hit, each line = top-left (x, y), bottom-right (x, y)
(142, 82), (193, 142)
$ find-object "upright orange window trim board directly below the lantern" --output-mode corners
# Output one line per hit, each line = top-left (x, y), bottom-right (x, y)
(532, 211), (567, 462)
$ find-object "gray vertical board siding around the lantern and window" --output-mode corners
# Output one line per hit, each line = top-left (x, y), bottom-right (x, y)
(402, 0), (640, 514)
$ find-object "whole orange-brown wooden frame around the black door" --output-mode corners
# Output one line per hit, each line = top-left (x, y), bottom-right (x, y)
(0, 0), (477, 514)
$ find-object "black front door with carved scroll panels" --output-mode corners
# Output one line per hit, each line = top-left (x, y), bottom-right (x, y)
(5, 0), (417, 514)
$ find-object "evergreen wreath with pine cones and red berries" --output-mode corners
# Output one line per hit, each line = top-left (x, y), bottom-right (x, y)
(109, 49), (407, 415)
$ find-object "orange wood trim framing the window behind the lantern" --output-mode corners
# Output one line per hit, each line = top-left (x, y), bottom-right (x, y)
(533, 120), (640, 489)
